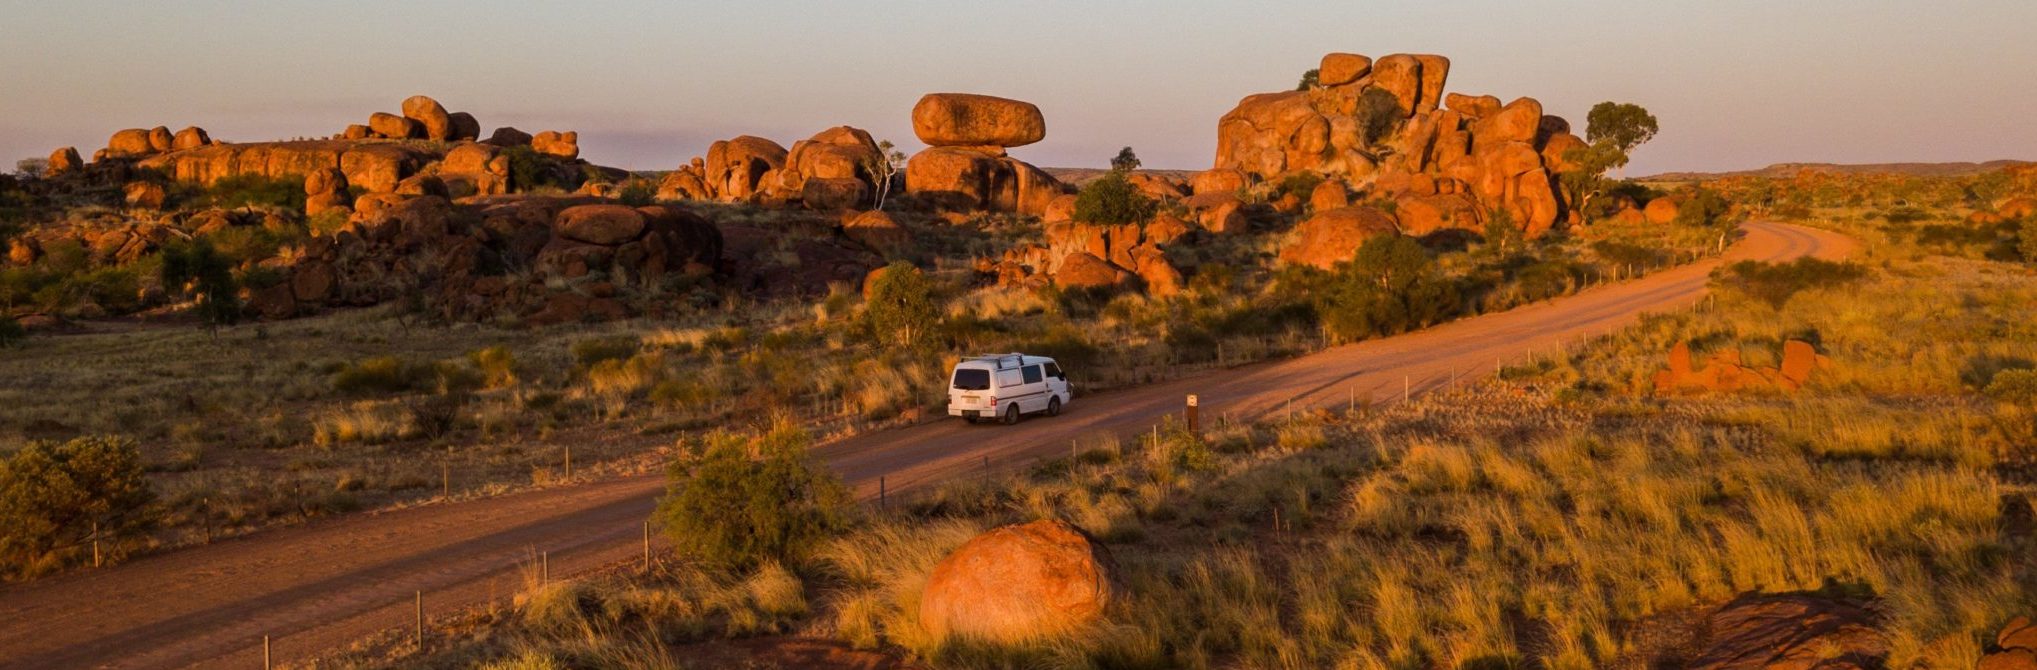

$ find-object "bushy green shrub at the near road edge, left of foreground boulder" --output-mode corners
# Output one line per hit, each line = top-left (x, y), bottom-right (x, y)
(652, 426), (854, 568)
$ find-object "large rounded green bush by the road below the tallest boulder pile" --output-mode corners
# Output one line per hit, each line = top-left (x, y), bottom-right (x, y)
(1316, 236), (1458, 340)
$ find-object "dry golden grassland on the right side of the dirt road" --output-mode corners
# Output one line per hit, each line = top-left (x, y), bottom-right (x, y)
(321, 176), (2037, 668)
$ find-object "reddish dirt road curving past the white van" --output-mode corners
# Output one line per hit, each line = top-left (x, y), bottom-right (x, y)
(0, 222), (1854, 668)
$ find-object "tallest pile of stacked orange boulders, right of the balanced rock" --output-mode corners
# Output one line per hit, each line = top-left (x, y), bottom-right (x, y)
(1194, 53), (1585, 245)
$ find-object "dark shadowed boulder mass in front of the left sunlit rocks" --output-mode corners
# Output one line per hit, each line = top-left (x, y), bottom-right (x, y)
(249, 193), (721, 324)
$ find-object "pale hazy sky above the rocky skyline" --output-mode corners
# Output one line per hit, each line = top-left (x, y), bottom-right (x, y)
(0, 0), (2037, 175)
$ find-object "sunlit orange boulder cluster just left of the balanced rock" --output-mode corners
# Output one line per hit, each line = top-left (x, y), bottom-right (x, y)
(658, 126), (888, 210)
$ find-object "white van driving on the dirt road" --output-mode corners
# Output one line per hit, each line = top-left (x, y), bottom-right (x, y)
(947, 354), (1069, 424)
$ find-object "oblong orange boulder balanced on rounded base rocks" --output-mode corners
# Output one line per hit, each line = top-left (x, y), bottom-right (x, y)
(904, 94), (1065, 214)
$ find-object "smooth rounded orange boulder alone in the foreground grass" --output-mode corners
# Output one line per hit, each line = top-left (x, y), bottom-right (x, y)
(919, 521), (1116, 641)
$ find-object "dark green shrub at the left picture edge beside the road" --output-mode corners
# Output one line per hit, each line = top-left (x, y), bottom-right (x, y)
(0, 438), (157, 576)
